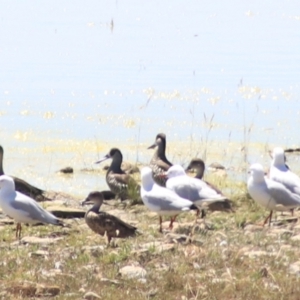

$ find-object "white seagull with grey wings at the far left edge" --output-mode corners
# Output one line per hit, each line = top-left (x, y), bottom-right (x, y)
(0, 175), (64, 239)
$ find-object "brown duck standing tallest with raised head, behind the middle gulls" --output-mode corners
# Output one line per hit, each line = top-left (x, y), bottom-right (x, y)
(148, 133), (172, 186)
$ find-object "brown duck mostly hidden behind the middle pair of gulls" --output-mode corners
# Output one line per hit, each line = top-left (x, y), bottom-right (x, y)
(186, 158), (234, 216)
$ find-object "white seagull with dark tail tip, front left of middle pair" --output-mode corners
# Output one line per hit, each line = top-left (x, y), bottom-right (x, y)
(141, 167), (197, 232)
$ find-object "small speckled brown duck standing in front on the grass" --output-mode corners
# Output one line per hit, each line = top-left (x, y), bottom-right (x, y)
(81, 192), (138, 244)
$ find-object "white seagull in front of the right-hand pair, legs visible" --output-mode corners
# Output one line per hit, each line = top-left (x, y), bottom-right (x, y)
(247, 164), (300, 226)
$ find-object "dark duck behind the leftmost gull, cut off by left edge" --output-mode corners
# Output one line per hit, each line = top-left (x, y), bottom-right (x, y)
(0, 146), (51, 201)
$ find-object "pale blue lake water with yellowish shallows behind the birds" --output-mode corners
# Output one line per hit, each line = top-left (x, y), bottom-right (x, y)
(0, 0), (300, 196)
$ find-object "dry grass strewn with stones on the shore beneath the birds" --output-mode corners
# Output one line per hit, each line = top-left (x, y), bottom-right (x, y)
(0, 173), (300, 300)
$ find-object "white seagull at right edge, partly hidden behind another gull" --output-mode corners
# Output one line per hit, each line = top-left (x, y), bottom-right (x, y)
(269, 147), (300, 196)
